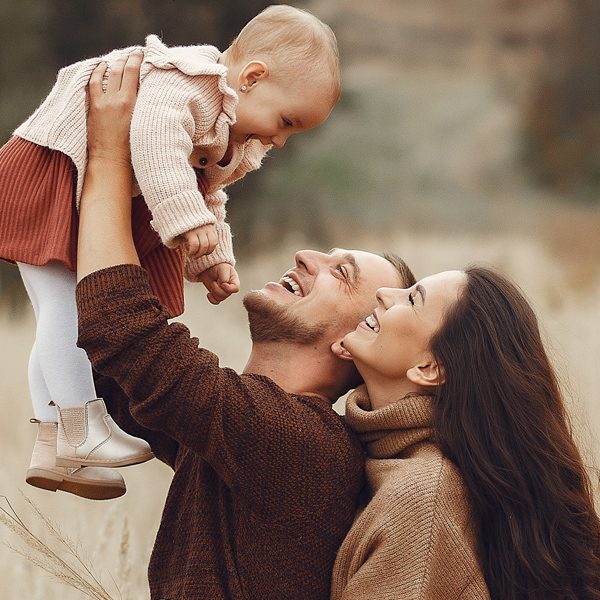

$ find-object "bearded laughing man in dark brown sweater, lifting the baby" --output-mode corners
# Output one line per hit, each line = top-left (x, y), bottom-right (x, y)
(77, 57), (412, 600)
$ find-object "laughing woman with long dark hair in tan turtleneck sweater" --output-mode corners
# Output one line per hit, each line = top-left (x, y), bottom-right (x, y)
(332, 267), (600, 600)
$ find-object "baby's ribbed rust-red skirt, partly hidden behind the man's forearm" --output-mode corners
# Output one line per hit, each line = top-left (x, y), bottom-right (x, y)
(0, 137), (183, 317)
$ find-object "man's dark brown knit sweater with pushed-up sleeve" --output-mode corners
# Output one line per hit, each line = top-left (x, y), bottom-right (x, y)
(77, 265), (363, 600)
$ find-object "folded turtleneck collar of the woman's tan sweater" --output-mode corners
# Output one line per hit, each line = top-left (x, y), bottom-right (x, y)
(346, 385), (432, 458)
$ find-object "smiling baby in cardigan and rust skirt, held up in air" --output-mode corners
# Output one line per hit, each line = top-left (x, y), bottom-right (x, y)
(0, 5), (340, 499)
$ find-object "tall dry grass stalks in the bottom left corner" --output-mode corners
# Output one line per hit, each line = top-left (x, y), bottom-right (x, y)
(0, 492), (119, 600)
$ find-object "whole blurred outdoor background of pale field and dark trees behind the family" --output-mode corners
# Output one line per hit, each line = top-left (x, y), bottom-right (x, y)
(0, 0), (600, 599)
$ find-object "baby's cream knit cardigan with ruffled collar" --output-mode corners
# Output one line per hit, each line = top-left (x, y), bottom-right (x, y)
(15, 35), (270, 281)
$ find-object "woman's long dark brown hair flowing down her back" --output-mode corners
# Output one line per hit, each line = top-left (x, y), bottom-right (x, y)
(431, 267), (600, 600)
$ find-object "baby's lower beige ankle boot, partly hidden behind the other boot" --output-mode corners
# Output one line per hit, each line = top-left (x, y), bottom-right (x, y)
(25, 419), (127, 500)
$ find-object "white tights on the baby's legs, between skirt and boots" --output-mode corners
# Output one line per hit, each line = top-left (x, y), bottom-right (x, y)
(17, 261), (96, 422)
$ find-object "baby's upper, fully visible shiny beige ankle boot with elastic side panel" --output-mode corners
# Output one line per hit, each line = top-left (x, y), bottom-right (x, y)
(56, 398), (154, 467)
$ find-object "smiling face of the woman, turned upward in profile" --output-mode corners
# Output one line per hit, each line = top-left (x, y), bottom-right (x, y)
(344, 271), (466, 385)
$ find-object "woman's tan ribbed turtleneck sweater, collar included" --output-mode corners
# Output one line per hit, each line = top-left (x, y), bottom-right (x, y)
(331, 387), (489, 600)
